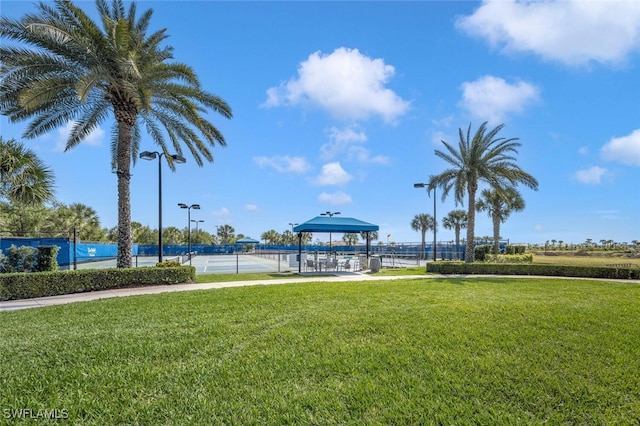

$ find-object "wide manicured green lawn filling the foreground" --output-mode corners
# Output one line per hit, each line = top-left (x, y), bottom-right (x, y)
(0, 278), (640, 425)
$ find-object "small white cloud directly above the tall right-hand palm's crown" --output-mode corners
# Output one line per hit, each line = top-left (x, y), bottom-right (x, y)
(460, 75), (540, 123)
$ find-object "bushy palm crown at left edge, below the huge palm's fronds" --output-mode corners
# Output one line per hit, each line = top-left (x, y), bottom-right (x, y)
(0, 136), (54, 205)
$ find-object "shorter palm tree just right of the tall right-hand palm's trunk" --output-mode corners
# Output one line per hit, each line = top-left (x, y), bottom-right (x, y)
(476, 188), (524, 254)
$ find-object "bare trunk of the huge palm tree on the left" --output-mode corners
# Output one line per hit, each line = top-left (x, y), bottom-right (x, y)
(116, 121), (131, 268)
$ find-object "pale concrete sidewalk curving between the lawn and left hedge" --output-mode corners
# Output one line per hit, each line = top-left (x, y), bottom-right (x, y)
(0, 272), (433, 311)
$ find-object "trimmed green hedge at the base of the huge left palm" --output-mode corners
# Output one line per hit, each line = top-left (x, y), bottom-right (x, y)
(0, 266), (196, 300)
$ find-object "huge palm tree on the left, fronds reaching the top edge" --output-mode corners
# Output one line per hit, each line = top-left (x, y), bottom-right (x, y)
(0, 0), (232, 267)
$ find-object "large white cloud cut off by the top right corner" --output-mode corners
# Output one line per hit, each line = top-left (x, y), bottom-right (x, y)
(456, 0), (640, 65)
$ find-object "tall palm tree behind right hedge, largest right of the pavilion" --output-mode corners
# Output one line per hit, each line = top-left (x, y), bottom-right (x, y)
(429, 121), (538, 262)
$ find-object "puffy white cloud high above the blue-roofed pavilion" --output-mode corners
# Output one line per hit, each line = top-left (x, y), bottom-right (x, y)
(263, 47), (409, 122)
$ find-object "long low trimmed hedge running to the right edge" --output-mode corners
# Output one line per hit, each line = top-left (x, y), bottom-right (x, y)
(427, 262), (640, 280)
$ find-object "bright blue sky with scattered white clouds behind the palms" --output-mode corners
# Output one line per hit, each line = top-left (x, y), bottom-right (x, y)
(0, 0), (640, 243)
